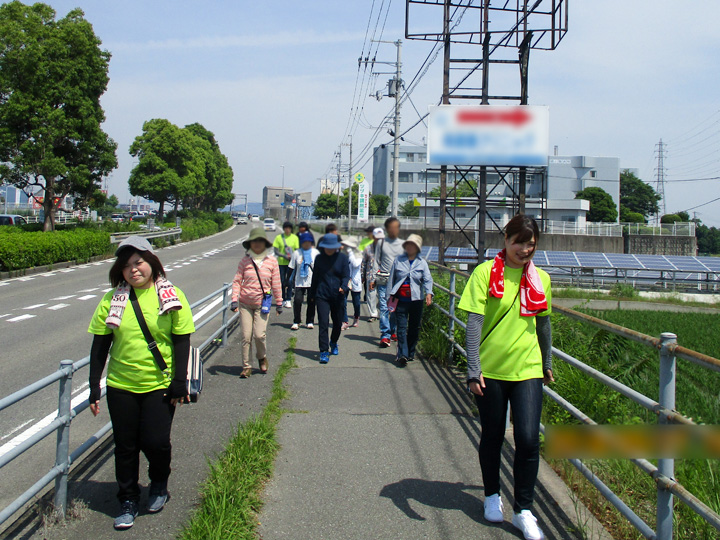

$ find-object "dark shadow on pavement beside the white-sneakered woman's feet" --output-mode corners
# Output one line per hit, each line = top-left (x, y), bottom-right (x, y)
(380, 478), (485, 523)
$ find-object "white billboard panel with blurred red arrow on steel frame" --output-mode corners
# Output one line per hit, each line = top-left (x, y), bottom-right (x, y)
(427, 105), (550, 167)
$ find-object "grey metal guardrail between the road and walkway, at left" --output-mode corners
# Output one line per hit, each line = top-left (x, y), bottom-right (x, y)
(0, 283), (239, 525)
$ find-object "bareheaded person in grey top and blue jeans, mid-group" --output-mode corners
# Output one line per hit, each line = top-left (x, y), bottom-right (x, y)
(370, 217), (403, 347)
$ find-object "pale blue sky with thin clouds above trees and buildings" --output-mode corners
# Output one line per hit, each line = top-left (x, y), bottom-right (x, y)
(38, 0), (720, 226)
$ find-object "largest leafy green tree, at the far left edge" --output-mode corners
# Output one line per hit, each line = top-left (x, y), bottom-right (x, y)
(0, 1), (117, 231)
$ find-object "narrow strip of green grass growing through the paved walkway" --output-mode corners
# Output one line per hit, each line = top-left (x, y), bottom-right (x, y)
(179, 337), (296, 540)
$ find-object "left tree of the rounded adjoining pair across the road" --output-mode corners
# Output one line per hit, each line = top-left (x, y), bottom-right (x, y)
(128, 118), (202, 216)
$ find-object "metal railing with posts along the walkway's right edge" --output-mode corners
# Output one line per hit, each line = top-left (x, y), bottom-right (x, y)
(429, 262), (720, 540)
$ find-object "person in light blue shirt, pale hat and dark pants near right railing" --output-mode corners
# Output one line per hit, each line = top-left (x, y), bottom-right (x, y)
(387, 234), (433, 367)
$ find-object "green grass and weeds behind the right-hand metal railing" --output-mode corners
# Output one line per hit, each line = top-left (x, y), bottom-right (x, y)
(420, 274), (720, 540)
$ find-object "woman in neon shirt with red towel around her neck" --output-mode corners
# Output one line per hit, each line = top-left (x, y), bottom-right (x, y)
(458, 215), (554, 540)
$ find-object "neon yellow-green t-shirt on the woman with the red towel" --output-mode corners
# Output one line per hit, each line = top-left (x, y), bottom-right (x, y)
(458, 261), (552, 381)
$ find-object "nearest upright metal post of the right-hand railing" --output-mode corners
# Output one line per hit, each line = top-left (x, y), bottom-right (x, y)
(657, 332), (677, 540)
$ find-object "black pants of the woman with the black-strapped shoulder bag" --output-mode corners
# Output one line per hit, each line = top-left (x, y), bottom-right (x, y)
(107, 386), (175, 502)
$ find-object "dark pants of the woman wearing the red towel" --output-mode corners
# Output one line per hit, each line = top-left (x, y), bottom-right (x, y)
(475, 378), (543, 513)
